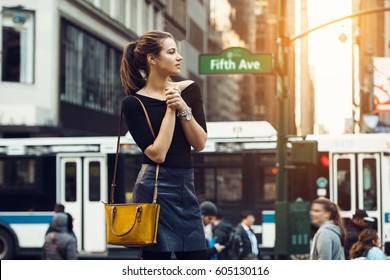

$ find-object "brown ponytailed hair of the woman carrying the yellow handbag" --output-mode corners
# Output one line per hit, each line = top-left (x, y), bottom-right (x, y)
(120, 31), (173, 95)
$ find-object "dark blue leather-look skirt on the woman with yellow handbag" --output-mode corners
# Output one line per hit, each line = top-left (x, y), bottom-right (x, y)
(133, 164), (206, 252)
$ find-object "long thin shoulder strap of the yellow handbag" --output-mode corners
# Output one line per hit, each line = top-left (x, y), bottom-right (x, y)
(110, 95), (160, 204)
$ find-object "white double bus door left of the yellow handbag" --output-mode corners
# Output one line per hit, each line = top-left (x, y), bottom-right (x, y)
(57, 155), (107, 253)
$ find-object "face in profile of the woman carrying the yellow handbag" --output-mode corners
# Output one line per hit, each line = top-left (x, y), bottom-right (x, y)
(155, 38), (183, 76)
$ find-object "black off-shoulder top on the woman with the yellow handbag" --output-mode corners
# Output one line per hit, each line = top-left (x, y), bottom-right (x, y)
(122, 83), (207, 168)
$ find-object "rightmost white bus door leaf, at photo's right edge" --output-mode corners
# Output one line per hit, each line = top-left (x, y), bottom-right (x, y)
(358, 153), (381, 232)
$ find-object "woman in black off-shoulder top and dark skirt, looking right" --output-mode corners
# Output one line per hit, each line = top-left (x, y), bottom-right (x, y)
(120, 31), (207, 259)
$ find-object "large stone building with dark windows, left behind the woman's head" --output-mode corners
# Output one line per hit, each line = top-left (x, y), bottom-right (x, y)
(0, 0), (208, 137)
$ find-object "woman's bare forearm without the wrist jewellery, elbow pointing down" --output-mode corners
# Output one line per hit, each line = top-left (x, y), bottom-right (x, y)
(145, 108), (176, 163)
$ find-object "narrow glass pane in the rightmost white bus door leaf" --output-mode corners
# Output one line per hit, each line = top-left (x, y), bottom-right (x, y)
(363, 158), (377, 211)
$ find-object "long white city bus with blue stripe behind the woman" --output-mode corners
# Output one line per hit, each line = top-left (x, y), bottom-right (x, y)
(0, 121), (390, 259)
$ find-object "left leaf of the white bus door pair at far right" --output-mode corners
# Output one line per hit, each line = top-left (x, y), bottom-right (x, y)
(330, 154), (356, 217)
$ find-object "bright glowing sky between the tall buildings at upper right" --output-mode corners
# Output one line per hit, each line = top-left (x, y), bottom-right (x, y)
(308, 0), (352, 134)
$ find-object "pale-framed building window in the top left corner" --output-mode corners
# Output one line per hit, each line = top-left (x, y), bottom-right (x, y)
(1, 9), (35, 84)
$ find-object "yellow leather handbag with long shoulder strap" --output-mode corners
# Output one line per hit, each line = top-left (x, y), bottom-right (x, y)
(103, 96), (160, 247)
